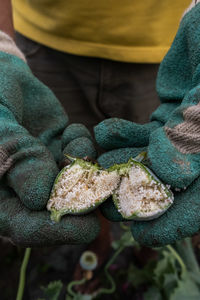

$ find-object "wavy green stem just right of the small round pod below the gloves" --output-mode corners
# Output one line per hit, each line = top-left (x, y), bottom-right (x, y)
(95, 246), (125, 296)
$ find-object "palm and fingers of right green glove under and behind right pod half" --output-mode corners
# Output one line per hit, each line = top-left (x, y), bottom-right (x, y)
(98, 148), (200, 247)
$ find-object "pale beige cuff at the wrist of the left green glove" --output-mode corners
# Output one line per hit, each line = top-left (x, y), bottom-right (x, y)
(0, 31), (26, 62)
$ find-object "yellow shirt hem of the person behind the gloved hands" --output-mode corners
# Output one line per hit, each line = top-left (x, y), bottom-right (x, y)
(13, 0), (191, 63)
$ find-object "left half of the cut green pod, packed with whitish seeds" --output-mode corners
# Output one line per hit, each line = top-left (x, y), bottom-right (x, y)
(47, 158), (120, 222)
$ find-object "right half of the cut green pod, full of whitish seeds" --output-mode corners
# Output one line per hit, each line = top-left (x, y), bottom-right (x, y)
(110, 158), (174, 220)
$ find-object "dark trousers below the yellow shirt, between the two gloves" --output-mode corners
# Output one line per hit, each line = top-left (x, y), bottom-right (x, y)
(16, 33), (159, 131)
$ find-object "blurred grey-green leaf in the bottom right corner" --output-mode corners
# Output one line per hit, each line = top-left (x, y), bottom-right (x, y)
(170, 273), (200, 300)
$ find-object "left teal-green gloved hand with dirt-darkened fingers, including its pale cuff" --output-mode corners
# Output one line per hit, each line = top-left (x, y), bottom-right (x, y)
(0, 32), (99, 246)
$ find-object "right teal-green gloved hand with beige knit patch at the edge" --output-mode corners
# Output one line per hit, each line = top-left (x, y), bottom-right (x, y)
(95, 1), (200, 246)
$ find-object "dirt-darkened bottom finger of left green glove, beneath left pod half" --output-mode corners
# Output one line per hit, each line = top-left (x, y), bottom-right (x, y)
(0, 181), (99, 247)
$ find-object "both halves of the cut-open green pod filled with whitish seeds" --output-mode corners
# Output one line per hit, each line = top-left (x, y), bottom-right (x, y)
(47, 157), (173, 221)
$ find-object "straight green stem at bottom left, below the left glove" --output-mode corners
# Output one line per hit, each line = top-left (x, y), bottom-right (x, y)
(16, 248), (31, 300)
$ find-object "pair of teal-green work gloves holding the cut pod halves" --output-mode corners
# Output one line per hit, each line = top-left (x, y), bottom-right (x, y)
(0, 1), (200, 246)
